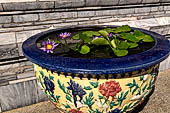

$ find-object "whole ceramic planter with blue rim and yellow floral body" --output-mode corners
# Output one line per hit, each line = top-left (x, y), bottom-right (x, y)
(23, 26), (170, 113)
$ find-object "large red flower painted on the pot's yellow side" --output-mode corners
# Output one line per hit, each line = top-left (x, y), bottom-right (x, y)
(99, 80), (122, 101)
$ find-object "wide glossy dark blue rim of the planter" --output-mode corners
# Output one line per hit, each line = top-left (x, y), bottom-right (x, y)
(22, 25), (170, 74)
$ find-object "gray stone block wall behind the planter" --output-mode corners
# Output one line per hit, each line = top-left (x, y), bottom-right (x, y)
(0, 0), (170, 112)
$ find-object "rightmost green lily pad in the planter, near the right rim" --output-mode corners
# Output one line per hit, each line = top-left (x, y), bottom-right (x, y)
(134, 30), (154, 42)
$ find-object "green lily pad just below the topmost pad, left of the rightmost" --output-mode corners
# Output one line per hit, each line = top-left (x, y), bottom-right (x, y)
(120, 32), (140, 43)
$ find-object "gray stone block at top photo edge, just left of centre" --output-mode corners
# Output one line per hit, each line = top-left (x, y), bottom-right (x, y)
(55, 0), (85, 8)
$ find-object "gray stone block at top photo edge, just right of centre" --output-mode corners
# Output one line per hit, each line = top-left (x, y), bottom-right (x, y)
(86, 0), (119, 6)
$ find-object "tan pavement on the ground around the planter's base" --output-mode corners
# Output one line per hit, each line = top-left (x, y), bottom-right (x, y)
(4, 69), (170, 113)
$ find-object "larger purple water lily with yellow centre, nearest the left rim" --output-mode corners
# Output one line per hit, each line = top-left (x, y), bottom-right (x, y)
(40, 39), (58, 53)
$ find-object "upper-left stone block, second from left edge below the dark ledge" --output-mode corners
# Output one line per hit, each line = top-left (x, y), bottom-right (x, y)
(13, 14), (38, 23)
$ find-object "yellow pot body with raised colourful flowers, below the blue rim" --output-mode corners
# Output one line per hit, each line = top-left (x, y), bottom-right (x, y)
(34, 65), (157, 113)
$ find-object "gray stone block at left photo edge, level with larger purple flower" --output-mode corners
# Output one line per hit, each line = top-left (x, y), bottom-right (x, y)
(0, 44), (19, 60)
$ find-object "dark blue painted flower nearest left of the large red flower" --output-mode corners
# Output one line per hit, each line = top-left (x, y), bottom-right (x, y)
(67, 80), (86, 107)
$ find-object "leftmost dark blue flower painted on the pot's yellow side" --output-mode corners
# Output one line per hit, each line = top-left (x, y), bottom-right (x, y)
(44, 76), (55, 94)
